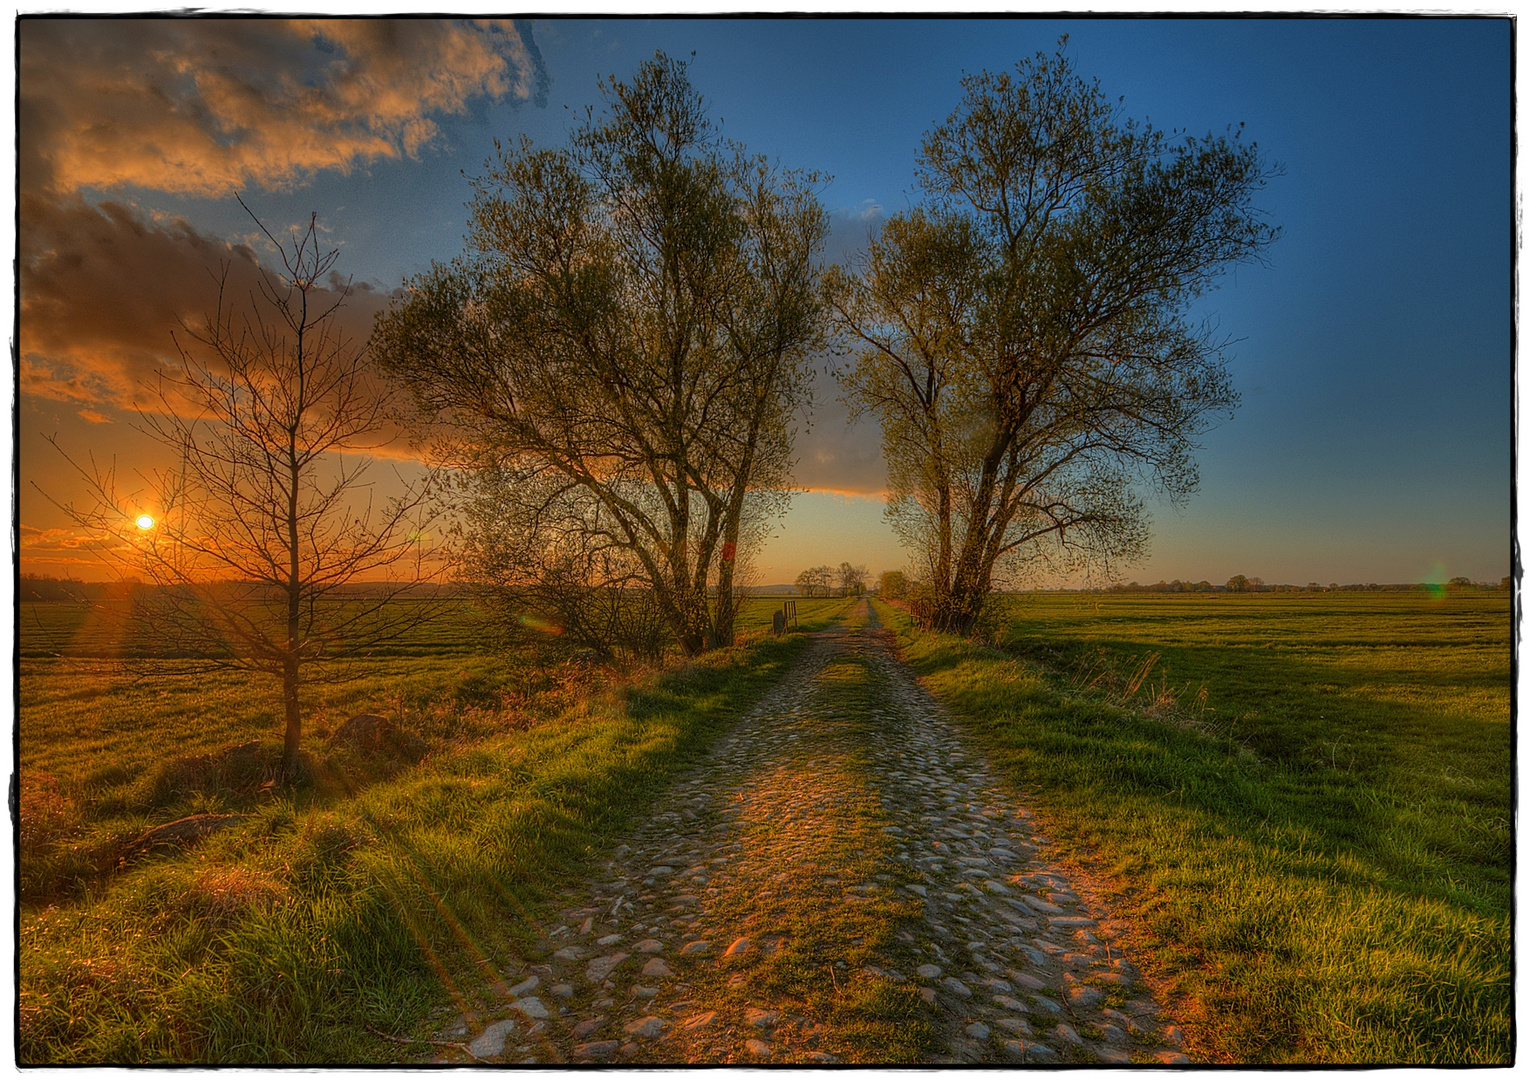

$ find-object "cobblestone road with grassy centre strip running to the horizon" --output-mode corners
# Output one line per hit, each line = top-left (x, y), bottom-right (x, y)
(425, 603), (1189, 1065)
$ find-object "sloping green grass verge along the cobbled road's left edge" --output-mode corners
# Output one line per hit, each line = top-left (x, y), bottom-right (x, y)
(17, 604), (843, 1065)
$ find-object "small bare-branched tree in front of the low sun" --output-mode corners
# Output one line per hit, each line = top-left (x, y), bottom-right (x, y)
(55, 208), (439, 779)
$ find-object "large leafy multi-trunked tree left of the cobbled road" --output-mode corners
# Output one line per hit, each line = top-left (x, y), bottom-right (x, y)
(376, 55), (828, 655)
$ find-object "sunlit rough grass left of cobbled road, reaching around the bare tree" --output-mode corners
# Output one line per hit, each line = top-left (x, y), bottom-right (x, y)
(17, 601), (843, 1063)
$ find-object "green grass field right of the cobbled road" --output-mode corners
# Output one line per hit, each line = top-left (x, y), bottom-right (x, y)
(887, 595), (1513, 1063)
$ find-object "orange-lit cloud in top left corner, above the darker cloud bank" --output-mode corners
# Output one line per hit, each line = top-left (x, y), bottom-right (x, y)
(18, 18), (548, 196)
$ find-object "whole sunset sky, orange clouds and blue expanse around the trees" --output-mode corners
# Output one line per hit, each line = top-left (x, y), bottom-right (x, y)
(17, 17), (1515, 584)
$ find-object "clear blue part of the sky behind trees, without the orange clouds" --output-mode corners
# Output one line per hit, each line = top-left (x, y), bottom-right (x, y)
(21, 18), (1513, 583)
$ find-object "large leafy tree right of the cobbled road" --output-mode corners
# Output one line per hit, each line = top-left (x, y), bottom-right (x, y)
(826, 47), (1274, 630)
